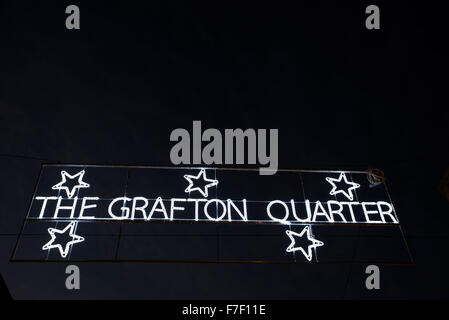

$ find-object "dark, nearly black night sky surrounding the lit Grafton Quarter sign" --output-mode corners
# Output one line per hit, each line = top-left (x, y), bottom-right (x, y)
(0, 1), (449, 299)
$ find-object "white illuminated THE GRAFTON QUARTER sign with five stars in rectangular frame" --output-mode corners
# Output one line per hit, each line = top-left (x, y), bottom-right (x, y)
(12, 165), (412, 262)
